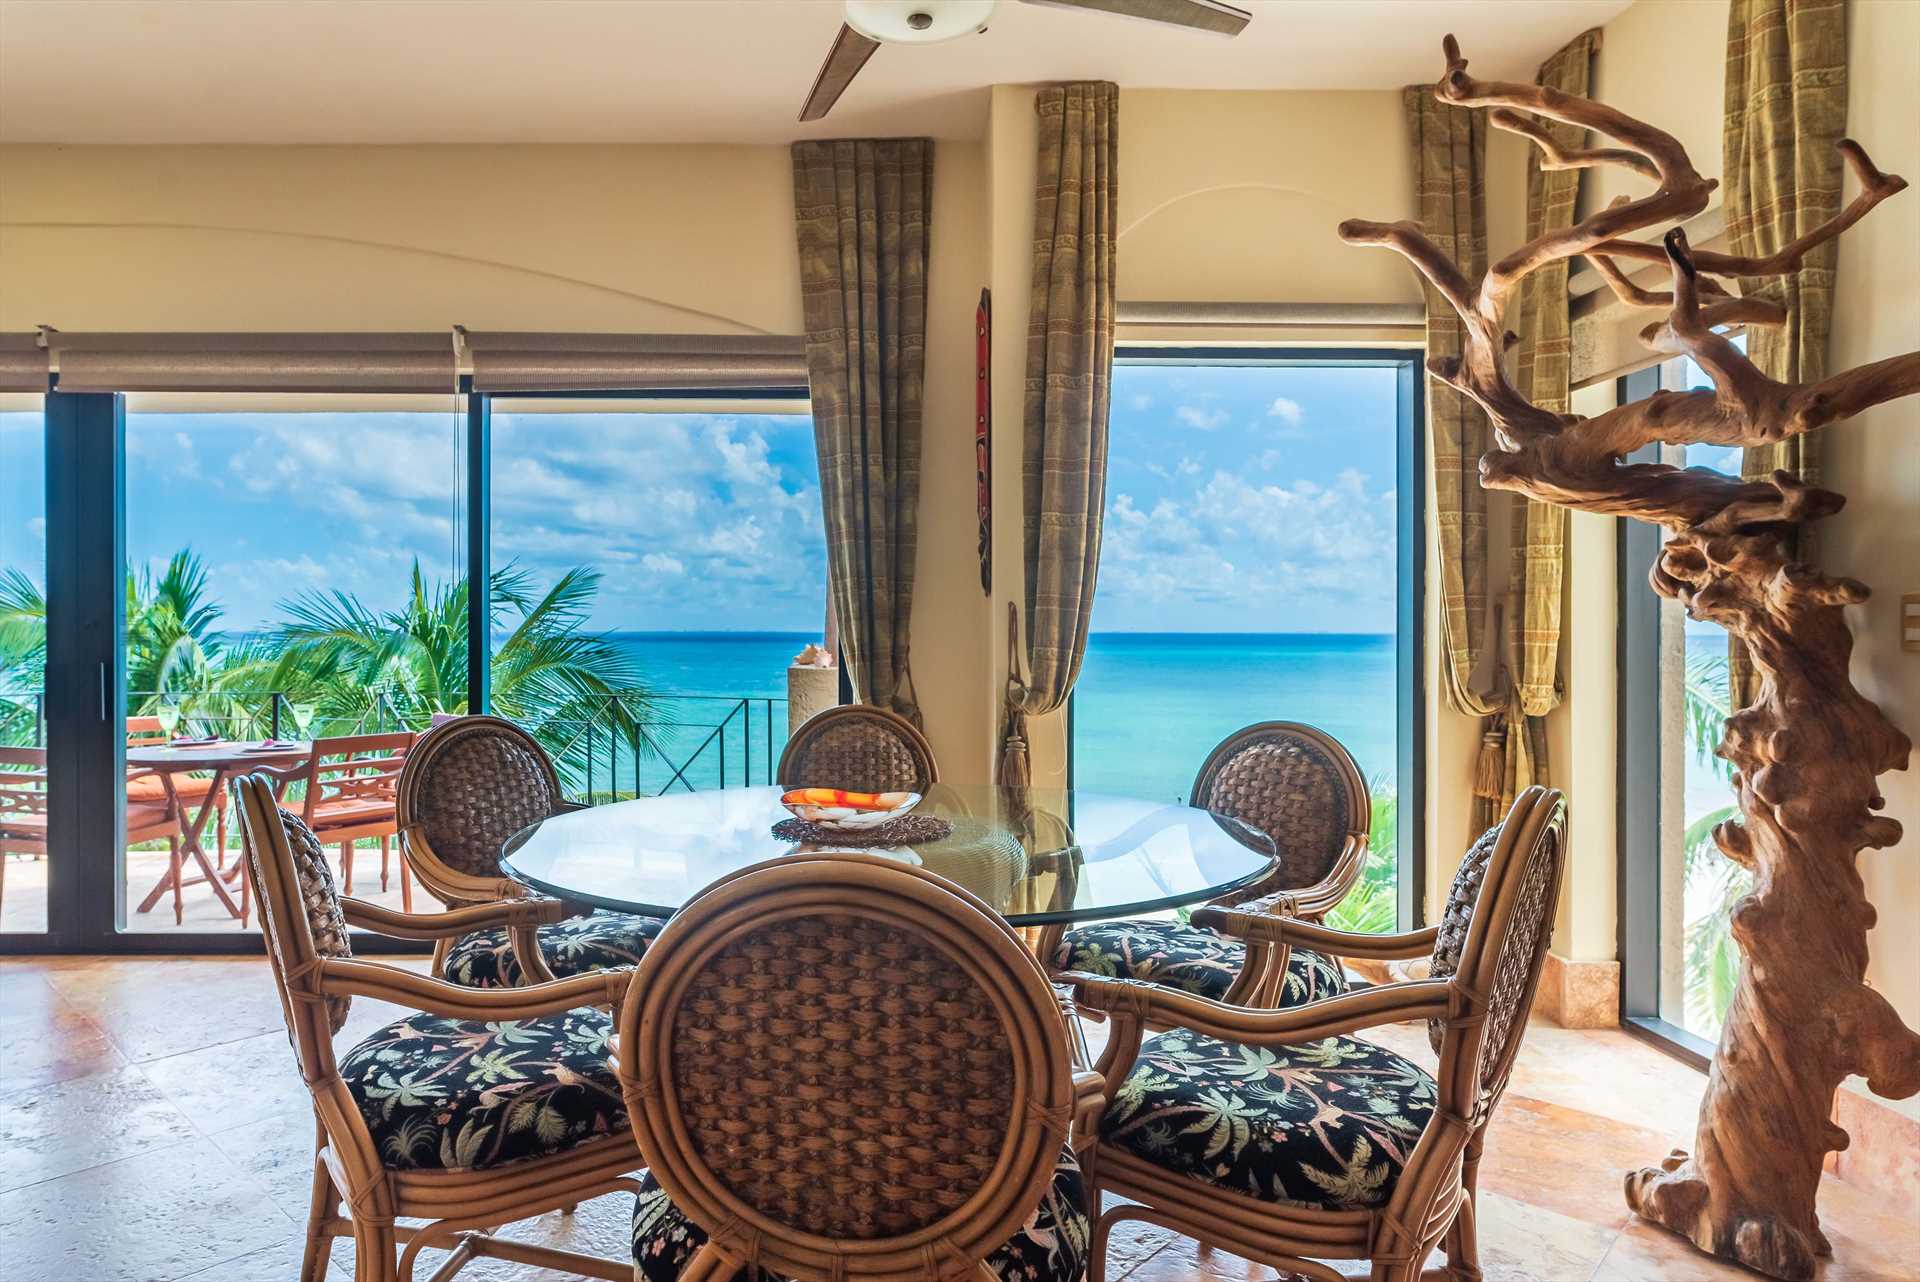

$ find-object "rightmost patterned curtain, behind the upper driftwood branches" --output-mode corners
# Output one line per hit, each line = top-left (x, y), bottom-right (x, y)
(1722, 0), (1847, 708)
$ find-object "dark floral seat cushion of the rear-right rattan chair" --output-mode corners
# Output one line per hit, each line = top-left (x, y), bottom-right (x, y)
(1054, 919), (1346, 1006)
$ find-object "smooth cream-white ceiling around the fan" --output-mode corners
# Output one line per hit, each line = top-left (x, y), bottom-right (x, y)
(0, 0), (1630, 144)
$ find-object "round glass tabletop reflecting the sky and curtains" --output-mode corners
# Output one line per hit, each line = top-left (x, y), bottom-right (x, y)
(503, 783), (1273, 925)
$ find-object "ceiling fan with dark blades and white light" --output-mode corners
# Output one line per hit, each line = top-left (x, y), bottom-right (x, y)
(801, 0), (1252, 121)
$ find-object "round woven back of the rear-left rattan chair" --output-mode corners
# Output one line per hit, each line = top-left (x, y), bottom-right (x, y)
(396, 716), (564, 879)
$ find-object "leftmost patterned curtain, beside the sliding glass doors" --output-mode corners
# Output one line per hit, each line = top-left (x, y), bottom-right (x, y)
(793, 138), (933, 725)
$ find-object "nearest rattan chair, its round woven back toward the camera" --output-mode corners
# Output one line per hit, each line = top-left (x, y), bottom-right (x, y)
(618, 854), (1102, 1282)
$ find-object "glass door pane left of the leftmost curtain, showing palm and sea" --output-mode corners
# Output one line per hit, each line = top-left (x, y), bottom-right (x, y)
(492, 397), (826, 800)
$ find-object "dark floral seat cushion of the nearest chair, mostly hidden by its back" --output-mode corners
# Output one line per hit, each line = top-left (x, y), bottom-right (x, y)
(634, 1150), (1089, 1282)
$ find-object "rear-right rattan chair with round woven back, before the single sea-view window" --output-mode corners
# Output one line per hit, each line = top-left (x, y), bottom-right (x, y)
(1043, 722), (1373, 1008)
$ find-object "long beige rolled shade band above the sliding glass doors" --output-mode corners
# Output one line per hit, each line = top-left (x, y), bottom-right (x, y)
(0, 326), (806, 393)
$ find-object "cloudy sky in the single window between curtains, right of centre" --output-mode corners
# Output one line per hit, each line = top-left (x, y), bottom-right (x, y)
(1094, 365), (1396, 631)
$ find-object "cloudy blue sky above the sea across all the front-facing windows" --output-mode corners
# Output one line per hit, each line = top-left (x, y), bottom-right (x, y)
(0, 365), (1394, 631)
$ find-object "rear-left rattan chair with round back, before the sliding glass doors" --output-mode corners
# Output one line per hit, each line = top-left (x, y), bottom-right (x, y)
(396, 716), (666, 988)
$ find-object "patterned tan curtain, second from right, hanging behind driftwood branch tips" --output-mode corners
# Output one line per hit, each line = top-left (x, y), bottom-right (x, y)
(1482, 29), (1599, 825)
